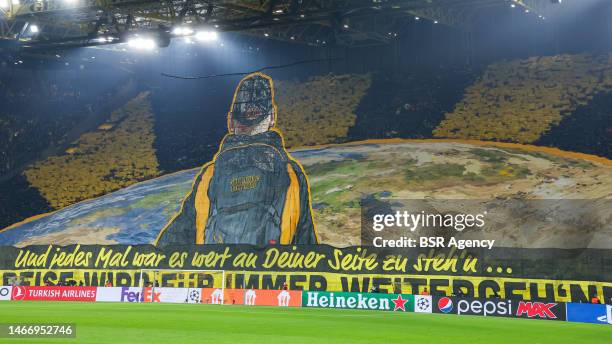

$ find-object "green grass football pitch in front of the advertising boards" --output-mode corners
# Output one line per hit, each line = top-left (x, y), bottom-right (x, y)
(0, 301), (612, 344)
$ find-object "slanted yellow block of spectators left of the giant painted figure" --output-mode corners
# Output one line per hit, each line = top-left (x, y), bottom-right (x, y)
(25, 93), (159, 208)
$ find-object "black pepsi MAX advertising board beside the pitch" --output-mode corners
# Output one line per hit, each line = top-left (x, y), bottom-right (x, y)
(432, 296), (567, 320)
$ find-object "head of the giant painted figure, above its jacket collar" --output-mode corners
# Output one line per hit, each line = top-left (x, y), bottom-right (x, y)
(227, 73), (276, 135)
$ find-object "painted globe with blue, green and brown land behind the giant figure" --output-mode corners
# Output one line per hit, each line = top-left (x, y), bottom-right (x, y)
(0, 140), (612, 248)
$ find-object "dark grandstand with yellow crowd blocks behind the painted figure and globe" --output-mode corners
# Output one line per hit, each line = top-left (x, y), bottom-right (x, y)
(0, 0), (612, 231)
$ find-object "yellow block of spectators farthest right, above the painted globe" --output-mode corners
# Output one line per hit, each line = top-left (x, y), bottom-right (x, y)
(433, 54), (612, 143)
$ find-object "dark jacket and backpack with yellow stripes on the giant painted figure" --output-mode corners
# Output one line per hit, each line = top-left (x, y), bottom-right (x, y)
(157, 130), (318, 245)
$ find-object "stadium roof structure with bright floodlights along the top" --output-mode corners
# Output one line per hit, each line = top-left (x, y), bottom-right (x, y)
(0, 0), (554, 49)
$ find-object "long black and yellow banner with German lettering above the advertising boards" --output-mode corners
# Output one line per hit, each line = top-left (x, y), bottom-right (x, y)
(0, 245), (612, 303)
